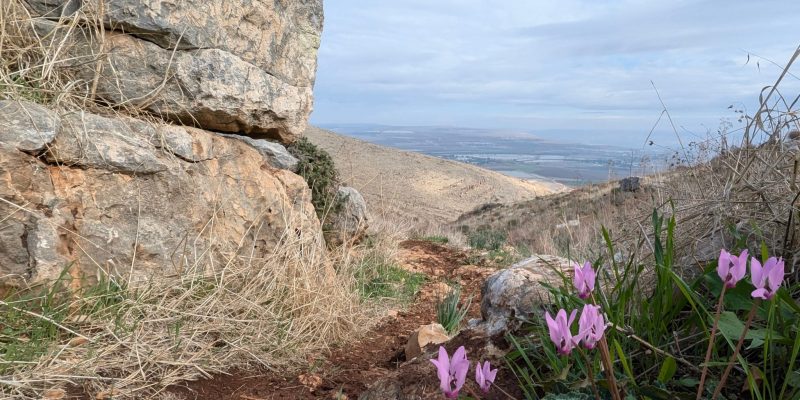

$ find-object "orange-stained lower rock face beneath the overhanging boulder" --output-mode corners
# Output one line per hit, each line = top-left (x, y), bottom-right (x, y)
(0, 101), (324, 287)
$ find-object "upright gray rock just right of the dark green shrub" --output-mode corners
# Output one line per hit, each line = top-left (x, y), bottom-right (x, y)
(325, 186), (370, 245)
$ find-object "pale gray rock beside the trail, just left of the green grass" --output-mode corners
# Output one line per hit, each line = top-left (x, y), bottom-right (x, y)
(481, 255), (571, 336)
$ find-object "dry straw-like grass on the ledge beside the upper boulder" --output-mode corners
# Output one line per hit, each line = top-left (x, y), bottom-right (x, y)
(0, 0), (194, 123)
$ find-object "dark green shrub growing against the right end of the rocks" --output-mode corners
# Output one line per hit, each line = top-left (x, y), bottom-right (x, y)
(287, 137), (345, 226)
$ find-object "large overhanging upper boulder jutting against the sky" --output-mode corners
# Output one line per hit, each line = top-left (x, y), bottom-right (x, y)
(26, 0), (323, 143)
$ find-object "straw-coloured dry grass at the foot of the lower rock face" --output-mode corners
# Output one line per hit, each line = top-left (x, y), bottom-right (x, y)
(0, 216), (367, 398)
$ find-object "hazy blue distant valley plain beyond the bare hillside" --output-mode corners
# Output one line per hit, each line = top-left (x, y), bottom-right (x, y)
(322, 124), (668, 187)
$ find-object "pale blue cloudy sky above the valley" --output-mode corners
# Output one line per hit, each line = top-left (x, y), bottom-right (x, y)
(311, 0), (800, 145)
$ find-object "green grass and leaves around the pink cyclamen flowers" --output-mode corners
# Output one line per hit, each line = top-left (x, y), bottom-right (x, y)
(507, 211), (800, 399)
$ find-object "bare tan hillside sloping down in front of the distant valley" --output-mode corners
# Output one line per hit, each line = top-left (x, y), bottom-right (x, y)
(305, 127), (565, 225)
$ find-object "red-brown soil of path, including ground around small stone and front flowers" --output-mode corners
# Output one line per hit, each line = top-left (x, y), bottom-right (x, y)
(166, 240), (516, 400)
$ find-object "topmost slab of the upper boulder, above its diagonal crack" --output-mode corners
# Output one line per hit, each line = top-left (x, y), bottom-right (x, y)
(98, 0), (323, 87)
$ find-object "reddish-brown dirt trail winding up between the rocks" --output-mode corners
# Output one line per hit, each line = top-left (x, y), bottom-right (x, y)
(173, 240), (494, 400)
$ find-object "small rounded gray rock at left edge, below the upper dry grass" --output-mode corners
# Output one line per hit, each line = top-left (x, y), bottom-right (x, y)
(0, 100), (59, 153)
